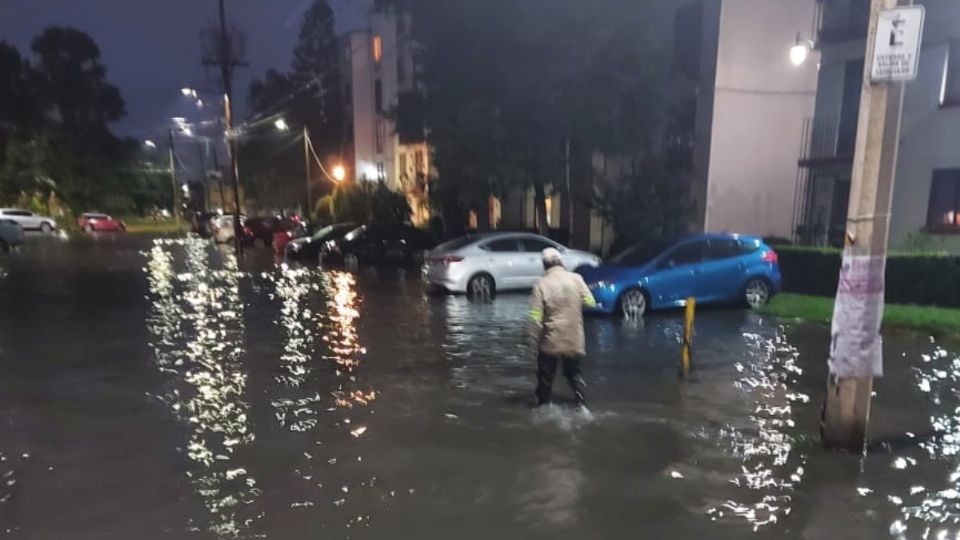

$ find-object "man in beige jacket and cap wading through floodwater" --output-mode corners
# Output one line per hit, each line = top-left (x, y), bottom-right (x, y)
(530, 248), (596, 408)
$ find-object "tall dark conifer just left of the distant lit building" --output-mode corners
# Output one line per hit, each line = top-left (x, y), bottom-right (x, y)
(240, 0), (344, 215)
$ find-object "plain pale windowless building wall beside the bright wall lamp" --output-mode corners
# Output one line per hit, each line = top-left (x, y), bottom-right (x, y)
(704, 0), (817, 237)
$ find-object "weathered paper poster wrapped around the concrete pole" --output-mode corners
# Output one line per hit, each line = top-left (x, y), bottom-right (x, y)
(829, 252), (886, 377)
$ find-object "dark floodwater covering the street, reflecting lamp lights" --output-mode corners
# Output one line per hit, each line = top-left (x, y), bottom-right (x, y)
(0, 236), (960, 540)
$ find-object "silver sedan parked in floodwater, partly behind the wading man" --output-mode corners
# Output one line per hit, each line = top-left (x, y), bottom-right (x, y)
(424, 233), (600, 295)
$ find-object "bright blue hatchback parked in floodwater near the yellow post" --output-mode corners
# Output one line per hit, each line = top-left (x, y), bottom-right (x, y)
(581, 234), (783, 317)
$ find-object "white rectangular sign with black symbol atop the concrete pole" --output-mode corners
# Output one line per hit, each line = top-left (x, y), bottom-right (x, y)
(870, 6), (925, 82)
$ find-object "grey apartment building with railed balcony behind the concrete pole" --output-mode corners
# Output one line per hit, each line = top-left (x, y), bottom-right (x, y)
(795, 0), (960, 252)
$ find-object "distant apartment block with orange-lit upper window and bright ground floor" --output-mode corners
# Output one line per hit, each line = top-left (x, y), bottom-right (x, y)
(343, 3), (430, 223)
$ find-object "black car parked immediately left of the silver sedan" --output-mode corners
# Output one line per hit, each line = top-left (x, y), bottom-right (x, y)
(320, 224), (437, 267)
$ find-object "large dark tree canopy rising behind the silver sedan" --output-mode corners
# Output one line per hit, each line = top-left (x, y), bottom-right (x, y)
(410, 0), (676, 240)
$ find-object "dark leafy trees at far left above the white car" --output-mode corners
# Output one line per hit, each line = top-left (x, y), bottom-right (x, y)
(0, 27), (155, 212)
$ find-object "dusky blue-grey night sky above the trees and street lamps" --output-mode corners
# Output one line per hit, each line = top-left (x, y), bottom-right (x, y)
(0, 0), (367, 142)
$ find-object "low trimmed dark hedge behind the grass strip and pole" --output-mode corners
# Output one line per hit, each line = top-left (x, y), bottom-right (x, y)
(774, 246), (960, 307)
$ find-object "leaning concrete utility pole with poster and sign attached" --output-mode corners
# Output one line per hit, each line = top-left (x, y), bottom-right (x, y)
(820, 0), (903, 452)
